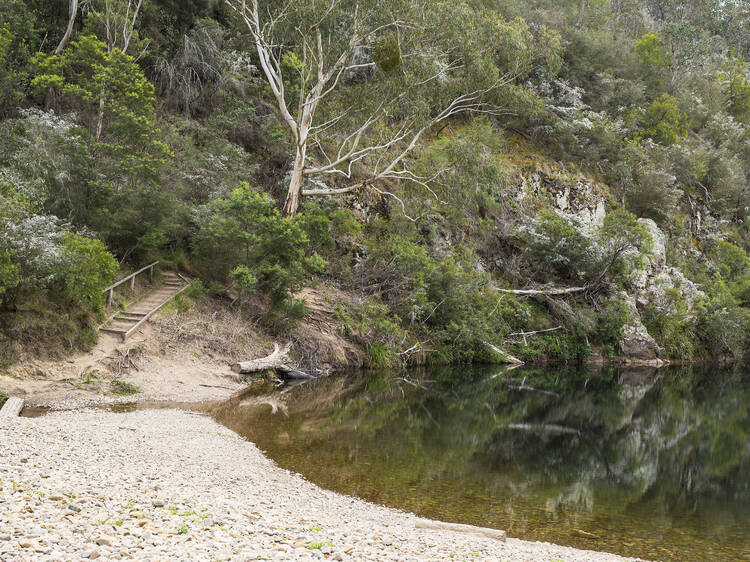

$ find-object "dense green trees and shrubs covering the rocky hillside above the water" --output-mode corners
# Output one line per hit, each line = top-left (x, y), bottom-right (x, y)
(0, 0), (750, 367)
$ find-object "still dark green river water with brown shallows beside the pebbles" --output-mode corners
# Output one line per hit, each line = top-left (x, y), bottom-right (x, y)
(215, 365), (750, 561)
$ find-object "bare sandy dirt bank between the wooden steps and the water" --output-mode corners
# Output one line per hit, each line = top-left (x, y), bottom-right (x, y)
(0, 289), (362, 409)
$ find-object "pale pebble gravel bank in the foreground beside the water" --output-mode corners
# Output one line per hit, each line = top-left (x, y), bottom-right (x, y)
(0, 410), (640, 562)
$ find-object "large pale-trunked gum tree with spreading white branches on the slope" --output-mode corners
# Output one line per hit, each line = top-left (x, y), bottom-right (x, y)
(226, 0), (526, 216)
